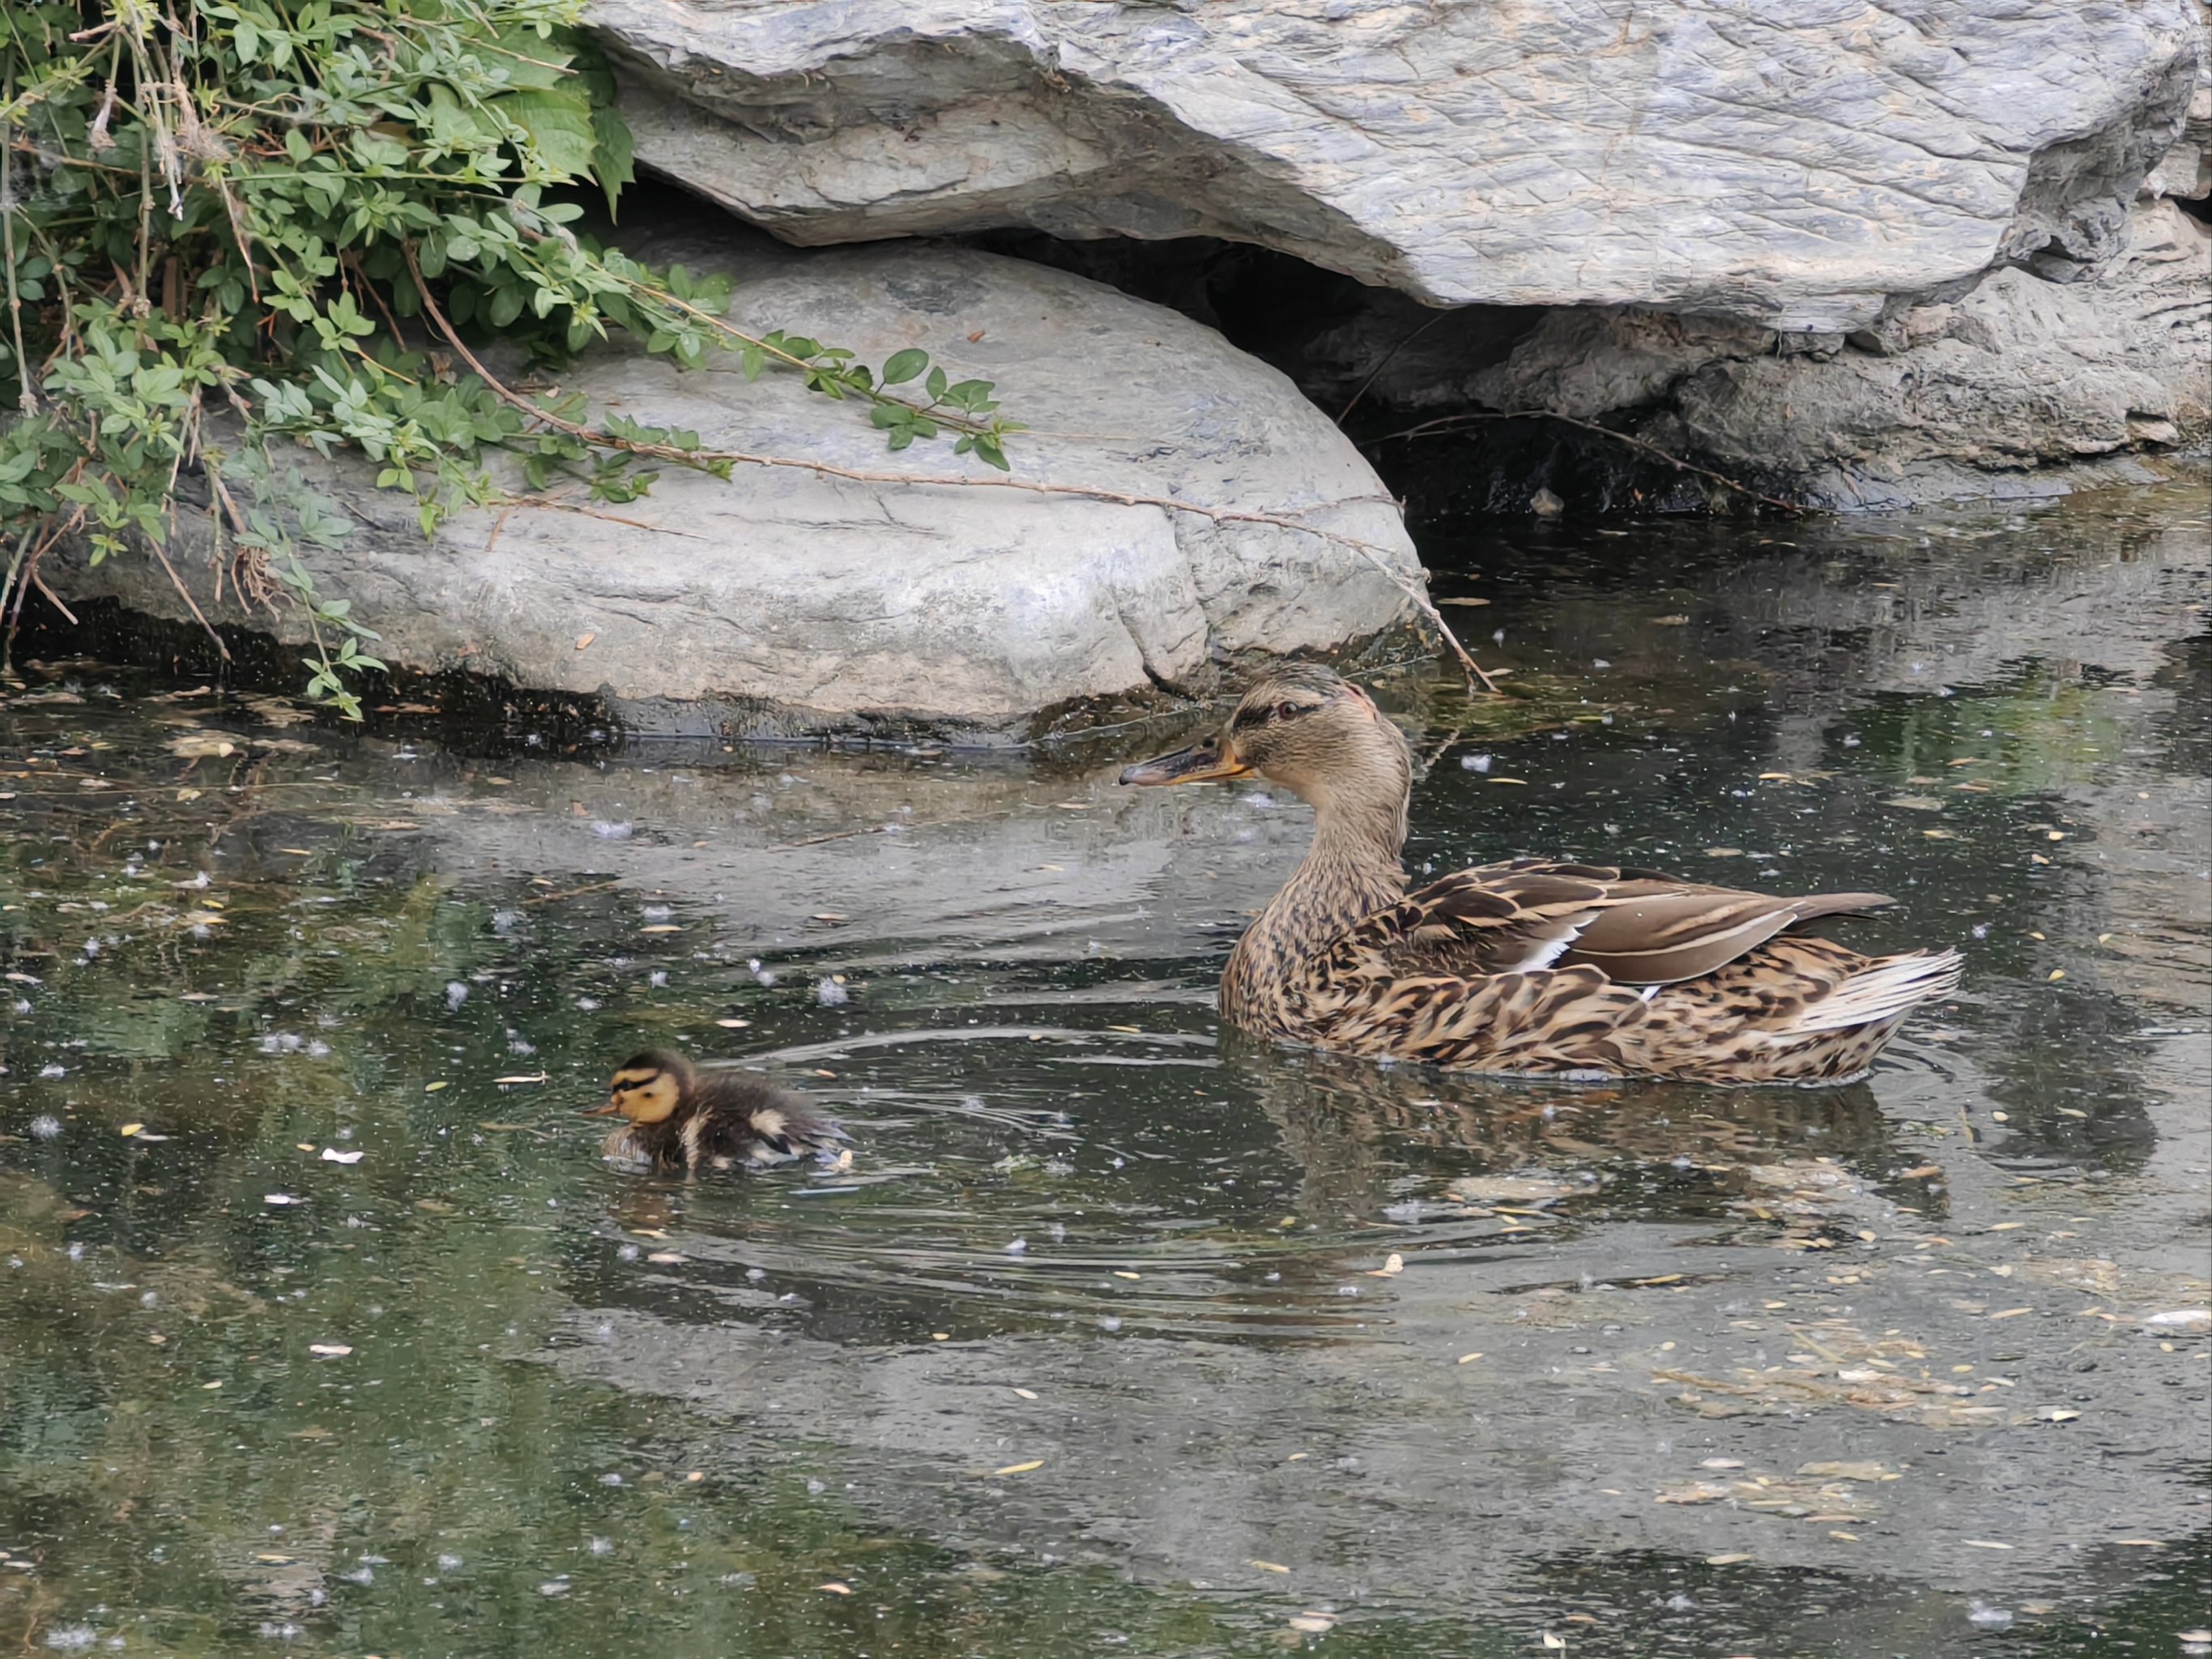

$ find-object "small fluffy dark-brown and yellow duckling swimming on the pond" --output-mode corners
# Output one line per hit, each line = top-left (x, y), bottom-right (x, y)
(584, 1048), (847, 1172)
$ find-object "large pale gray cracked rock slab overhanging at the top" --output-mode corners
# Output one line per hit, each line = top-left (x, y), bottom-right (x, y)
(590, 0), (2203, 332)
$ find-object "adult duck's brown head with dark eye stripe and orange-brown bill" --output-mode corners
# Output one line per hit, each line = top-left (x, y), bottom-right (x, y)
(1122, 663), (1413, 841)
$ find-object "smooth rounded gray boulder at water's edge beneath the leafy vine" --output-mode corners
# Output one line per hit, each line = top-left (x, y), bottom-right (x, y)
(49, 232), (1420, 736)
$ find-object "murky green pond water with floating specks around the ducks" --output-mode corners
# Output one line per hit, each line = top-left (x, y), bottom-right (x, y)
(0, 488), (2212, 1659)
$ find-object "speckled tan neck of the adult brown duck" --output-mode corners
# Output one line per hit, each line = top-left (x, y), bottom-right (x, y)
(1221, 792), (1407, 1035)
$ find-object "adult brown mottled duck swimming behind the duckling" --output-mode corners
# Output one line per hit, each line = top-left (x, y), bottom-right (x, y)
(1122, 663), (1960, 1084)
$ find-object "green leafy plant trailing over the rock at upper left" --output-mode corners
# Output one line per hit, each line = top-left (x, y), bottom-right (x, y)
(0, 0), (1020, 719)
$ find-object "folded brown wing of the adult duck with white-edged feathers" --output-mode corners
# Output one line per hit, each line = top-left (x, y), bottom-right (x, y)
(1316, 858), (1895, 984)
